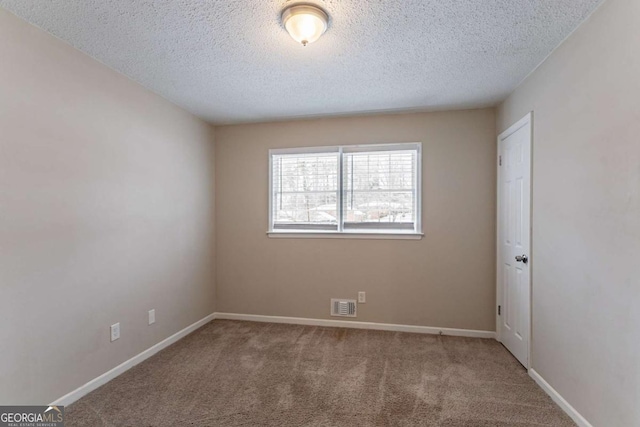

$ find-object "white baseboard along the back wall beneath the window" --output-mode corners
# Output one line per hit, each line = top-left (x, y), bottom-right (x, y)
(213, 313), (496, 339)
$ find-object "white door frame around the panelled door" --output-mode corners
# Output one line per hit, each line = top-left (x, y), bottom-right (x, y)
(495, 111), (535, 370)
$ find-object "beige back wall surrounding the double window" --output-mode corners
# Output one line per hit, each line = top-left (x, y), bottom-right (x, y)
(216, 109), (496, 331)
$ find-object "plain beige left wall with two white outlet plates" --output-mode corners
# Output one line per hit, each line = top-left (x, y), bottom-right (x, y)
(0, 9), (215, 404)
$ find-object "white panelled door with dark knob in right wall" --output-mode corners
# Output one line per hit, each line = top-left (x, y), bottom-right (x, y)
(497, 114), (531, 369)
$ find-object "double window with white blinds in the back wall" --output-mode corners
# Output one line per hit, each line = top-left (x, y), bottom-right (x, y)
(269, 143), (421, 235)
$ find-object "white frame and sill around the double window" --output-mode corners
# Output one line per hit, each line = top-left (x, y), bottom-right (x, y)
(267, 142), (424, 240)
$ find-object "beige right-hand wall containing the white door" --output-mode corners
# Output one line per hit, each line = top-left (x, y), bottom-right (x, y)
(498, 0), (640, 426)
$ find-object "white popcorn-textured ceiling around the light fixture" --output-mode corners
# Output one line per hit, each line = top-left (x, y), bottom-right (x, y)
(0, 0), (601, 123)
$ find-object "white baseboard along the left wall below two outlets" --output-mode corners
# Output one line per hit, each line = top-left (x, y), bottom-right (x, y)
(50, 314), (215, 406)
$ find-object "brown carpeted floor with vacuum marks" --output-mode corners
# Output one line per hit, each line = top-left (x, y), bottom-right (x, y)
(65, 320), (574, 427)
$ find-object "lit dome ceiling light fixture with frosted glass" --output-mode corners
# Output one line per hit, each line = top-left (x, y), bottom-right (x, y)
(282, 4), (329, 46)
